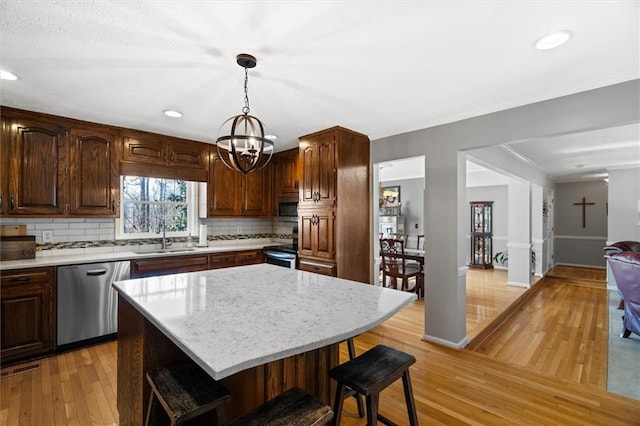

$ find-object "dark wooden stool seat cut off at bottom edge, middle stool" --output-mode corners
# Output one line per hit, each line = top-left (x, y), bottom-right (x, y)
(225, 388), (333, 426)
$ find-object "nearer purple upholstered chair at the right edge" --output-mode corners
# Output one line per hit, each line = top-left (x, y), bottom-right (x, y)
(609, 251), (640, 337)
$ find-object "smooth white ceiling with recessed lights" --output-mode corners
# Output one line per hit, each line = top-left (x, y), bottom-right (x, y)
(0, 0), (640, 179)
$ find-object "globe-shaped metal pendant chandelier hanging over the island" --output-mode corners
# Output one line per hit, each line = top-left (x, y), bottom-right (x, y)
(216, 53), (273, 174)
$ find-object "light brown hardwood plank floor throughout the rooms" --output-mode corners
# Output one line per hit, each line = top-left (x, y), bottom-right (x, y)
(0, 271), (640, 426)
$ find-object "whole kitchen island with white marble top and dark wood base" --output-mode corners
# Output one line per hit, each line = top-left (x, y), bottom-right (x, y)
(113, 264), (415, 425)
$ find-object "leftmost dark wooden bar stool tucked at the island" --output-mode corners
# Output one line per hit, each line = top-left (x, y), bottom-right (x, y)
(145, 362), (231, 426)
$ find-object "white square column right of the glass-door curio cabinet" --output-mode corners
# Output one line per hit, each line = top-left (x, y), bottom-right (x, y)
(507, 179), (531, 288)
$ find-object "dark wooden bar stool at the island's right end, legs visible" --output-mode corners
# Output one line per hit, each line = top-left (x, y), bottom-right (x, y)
(329, 345), (418, 426)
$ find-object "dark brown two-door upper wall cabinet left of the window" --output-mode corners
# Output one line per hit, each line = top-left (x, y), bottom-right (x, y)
(0, 107), (120, 217)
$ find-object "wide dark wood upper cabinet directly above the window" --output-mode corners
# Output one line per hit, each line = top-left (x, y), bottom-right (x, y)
(121, 130), (209, 182)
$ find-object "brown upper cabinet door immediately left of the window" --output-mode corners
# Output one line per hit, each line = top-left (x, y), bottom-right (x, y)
(69, 129), (120, 217)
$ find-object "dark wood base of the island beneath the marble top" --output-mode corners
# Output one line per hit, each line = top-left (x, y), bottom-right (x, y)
(117, 295), (339, 426)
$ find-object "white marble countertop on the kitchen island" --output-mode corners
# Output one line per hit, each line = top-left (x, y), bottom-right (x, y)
(113, 263), (416, 380)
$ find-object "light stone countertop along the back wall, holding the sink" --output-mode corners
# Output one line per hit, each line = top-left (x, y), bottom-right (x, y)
(0, 239), (284, 271)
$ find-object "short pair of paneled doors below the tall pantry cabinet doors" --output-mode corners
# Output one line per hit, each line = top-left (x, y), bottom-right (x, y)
(298, 209), (335, 260)
